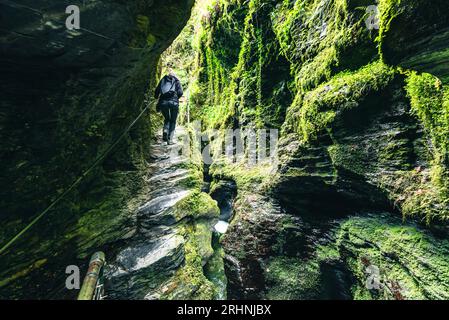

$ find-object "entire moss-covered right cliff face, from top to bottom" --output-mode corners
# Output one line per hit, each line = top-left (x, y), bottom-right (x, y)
(188, 0), (449, 299)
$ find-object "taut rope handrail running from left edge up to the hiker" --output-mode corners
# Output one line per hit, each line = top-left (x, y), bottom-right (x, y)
(0, 96), (152, 255)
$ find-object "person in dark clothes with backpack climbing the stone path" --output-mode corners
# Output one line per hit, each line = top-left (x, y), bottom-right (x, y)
(154, 69), (183, 145)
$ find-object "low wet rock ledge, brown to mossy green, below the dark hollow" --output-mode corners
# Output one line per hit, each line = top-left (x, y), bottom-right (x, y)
(223, 190), (449, 300)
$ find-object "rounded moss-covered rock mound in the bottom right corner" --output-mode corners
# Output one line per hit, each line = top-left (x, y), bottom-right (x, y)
(337, 215), (449, 299)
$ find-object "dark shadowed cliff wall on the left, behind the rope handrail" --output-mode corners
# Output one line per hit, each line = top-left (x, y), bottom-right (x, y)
(0, 0), (194, 298)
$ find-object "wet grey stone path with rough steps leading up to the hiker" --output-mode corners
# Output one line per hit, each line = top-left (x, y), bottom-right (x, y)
(106, 127), (218, 299)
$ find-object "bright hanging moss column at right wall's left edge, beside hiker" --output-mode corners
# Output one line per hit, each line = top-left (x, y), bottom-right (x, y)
(178, 1), (244, 127)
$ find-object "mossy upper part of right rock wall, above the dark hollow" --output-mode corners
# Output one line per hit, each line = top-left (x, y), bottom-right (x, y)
(188, 0), (449, 222)
